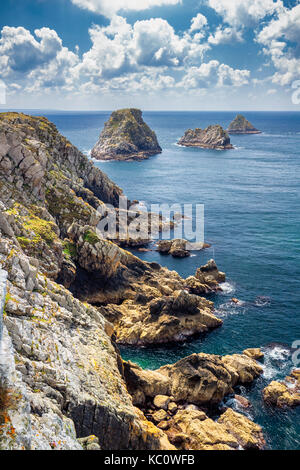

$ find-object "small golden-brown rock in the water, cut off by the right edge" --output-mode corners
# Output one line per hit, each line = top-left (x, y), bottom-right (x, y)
(263, 369), (300, 407)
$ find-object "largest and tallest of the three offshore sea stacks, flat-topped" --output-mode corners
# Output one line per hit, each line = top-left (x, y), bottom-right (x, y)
(91, 109), (162, 160)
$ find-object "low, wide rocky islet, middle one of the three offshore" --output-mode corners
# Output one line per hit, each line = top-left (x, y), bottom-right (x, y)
(178, 125), (233, 150)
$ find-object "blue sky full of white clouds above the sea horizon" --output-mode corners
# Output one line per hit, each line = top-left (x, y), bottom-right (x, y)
(0, 0), (300, 111)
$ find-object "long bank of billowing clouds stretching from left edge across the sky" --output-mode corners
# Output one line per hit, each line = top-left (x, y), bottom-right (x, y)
(0, 14), (250, 100)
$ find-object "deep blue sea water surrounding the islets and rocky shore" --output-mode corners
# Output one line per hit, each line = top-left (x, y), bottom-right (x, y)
(22, 111), (300, 449)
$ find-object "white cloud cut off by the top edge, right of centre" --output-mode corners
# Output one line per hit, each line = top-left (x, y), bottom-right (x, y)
(207, 0), (283, 27)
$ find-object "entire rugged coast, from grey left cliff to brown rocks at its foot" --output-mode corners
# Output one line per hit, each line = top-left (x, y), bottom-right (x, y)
(0, 113), (288, 450)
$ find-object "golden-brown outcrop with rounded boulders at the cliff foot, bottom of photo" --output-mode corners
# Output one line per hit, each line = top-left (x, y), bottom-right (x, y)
(124, 354), (265, 450)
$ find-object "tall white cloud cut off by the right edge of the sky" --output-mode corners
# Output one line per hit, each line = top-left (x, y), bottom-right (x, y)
(257, 5), (300, 85)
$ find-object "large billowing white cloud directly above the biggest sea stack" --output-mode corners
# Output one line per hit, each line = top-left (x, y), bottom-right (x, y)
(77, 16), (207, 80)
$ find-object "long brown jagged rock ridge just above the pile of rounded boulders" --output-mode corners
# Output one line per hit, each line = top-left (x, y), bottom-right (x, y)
(124, 353), (263, 406)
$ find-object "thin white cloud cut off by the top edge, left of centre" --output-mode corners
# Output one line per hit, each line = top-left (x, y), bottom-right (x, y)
(71, 0), (181, 17)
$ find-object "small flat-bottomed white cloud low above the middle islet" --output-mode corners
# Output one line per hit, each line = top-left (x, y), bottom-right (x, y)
(178, 60), (250, 89)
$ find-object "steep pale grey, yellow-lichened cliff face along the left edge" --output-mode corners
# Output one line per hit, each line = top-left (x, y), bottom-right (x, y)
(0, 113), (172, 449)
